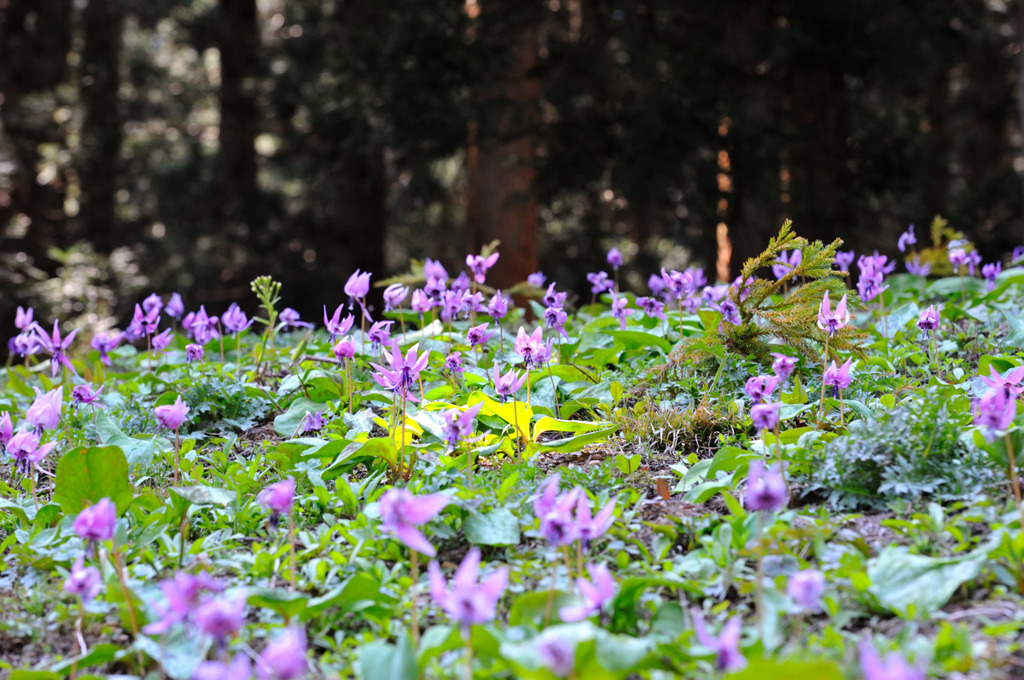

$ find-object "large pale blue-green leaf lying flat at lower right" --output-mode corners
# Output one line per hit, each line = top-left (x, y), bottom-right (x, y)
(867, 546), (987, 615)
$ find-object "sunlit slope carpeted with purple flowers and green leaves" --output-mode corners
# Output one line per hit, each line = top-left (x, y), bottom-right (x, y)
(0, 221), (1024, 680)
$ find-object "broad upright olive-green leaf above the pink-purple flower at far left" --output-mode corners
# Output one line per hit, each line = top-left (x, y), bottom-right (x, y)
(53, 447), (133, 515)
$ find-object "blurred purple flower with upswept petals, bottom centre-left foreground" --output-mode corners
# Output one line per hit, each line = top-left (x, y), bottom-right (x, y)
(429, 546), (509, 636)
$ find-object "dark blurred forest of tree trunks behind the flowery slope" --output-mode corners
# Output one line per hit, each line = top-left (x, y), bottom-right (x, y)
(0, 0), (1024, 336)
